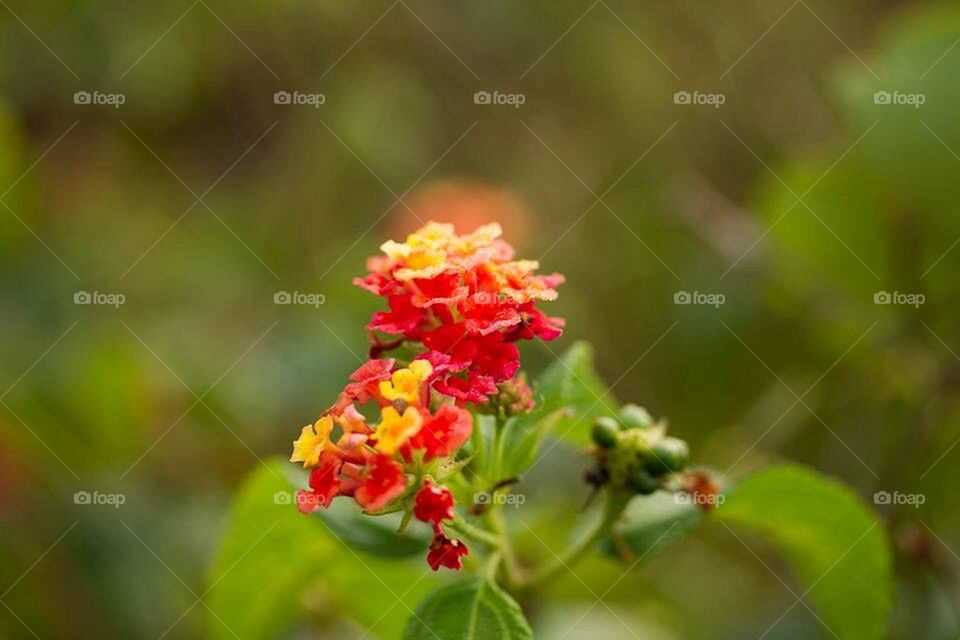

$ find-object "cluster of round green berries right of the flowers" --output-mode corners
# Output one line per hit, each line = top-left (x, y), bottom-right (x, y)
(586, 404), (690, 495)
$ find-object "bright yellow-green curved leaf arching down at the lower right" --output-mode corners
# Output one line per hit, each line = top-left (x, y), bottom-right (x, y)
(715, 465), (892, 640)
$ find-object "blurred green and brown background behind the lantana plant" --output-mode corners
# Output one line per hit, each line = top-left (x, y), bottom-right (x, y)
(0, 0), (960, 639)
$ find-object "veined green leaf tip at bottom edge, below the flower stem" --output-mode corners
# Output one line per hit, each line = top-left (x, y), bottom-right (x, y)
(403, 578), (533, 640)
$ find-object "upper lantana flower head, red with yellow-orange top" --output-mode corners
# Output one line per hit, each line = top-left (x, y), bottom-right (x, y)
(354, 222), (563, 403)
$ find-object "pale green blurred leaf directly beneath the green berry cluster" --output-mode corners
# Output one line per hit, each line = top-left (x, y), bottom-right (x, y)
(601, 493), (703, 561)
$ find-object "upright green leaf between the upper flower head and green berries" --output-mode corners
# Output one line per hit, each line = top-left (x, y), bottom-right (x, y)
(517, 341), (619, 445)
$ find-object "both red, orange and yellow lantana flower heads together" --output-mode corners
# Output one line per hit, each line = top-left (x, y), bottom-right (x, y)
(290, 222), (563, 570)
